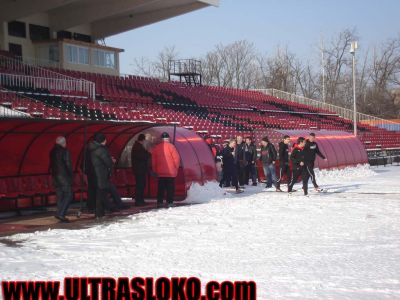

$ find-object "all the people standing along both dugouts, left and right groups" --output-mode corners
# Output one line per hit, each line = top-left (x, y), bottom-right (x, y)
(50, 132), (326, 222)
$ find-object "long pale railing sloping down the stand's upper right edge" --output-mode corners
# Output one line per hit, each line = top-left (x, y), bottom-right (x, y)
(254, 89), (399, 131)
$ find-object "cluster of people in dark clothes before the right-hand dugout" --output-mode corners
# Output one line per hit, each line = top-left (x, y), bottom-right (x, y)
(220, 133), (326, 195)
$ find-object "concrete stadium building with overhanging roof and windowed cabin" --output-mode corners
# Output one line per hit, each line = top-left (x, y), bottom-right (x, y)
(0, 0), (219, 75)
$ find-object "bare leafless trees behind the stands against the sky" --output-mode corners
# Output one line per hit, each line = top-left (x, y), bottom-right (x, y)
(130, 29), (400, 117)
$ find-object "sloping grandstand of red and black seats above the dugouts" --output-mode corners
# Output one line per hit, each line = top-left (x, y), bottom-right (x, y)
(0, 53), (400, 149)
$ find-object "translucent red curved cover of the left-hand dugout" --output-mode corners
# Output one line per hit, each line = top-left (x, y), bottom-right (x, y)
(0, 119), (216, 202)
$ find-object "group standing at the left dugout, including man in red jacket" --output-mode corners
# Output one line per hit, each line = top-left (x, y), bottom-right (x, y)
(50, 132), (180, 222)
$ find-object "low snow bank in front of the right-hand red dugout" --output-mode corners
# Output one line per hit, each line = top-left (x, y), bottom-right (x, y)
(315, 164), (377, 184)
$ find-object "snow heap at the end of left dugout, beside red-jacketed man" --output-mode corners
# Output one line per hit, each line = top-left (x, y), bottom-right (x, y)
(185, 181), (226, 204)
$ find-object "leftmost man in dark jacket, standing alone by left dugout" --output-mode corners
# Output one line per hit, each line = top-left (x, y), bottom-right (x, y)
(50, 136), (73, 222)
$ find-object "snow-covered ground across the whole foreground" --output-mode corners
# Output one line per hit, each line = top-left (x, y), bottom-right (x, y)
(0, 166), (400, 299)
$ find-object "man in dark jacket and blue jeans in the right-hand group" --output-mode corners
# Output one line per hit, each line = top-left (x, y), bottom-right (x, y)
(260, 136), (280, 192)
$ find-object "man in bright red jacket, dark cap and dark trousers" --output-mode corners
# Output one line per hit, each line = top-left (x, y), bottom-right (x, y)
(151, 132), (181, 207)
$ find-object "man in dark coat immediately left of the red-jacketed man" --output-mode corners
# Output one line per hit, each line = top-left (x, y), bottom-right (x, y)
(131, 133), (150, 206)
